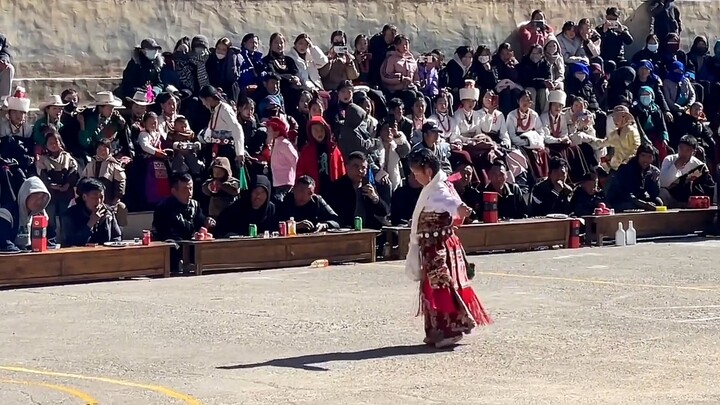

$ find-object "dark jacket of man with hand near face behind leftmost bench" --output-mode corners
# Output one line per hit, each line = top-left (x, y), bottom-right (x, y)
(62, 198), (122, 246)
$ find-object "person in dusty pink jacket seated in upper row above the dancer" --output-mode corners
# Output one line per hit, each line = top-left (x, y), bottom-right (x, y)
(382, 35), (422, 110)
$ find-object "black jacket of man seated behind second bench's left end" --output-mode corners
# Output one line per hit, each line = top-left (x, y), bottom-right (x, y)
(153, 196), (205, 241)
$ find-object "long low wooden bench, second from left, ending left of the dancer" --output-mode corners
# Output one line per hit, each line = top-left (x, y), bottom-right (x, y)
(180, 230), (378, 275)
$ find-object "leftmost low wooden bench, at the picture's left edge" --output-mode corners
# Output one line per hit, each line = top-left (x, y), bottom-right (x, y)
(0, 242), (172, 287)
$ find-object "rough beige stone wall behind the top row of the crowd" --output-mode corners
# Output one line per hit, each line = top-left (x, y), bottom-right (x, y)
(0, 0), (720, 78)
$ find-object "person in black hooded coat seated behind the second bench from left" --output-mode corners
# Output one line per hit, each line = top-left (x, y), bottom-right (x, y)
(215, 175), (278, 237)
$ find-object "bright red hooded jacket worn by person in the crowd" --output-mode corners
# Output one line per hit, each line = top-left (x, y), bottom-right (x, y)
(296, 117), (345, 193)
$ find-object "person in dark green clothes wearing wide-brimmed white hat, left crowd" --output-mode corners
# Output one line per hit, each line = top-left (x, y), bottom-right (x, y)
(78, 91), (134, 162)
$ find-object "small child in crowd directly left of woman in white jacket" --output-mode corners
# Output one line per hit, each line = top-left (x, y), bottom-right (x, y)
(164, 115), (203, 177)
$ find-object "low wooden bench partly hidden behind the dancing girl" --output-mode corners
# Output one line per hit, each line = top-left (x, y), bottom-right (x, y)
(383, 218), (571, 260)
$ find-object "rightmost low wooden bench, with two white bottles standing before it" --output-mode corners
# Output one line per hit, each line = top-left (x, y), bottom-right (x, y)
(583, 207), (717, 246)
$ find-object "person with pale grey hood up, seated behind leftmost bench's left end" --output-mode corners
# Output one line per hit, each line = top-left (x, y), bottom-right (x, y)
(6, 176), (56, 250)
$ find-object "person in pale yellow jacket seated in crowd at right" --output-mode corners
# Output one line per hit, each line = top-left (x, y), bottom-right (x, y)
(599, 105), (641, 171)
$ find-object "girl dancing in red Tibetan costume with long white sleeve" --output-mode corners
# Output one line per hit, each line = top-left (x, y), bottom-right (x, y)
(405, 149), (492, 348)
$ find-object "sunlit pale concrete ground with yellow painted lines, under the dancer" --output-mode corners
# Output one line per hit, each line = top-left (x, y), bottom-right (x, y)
(0, 241), (720, 405)
